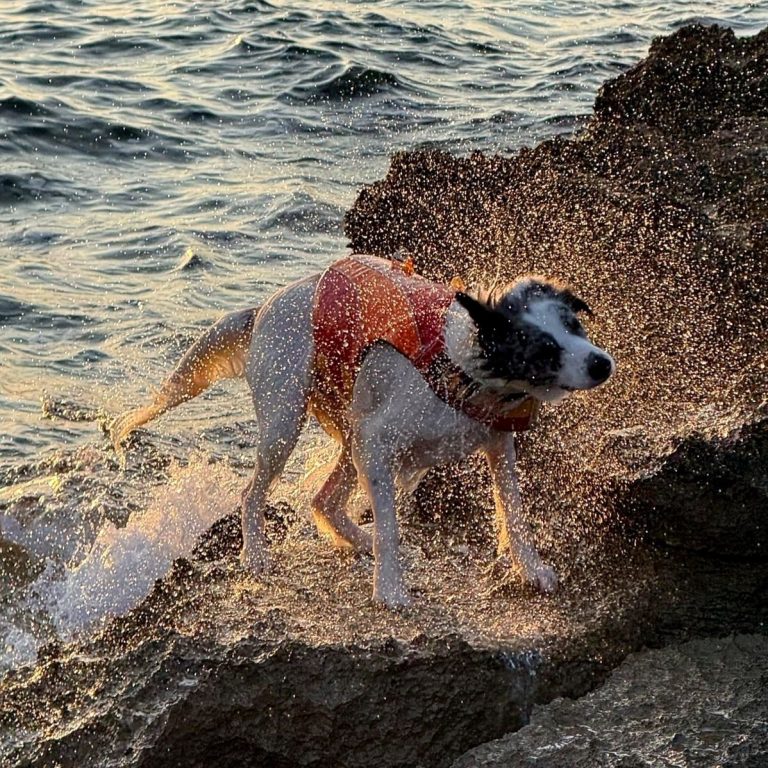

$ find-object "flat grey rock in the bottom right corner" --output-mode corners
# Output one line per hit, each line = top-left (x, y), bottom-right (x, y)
(453, 635), (768, 768)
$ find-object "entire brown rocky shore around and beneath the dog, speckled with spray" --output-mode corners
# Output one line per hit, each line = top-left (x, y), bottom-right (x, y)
(0, 21), (768, 768)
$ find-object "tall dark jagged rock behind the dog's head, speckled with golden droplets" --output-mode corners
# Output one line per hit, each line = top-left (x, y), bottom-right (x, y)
(346, 25), (768, 561)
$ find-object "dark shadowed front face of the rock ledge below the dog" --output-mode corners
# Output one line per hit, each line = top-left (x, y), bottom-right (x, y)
(136, 639), (530, 768)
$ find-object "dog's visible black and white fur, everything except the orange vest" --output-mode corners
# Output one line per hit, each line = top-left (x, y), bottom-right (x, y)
(112, 264), (614, 607)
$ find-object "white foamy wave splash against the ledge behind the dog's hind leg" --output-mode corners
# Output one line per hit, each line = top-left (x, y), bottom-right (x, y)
(0, 455), (242, 669)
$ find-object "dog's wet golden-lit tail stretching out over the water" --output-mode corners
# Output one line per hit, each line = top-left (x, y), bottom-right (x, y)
(109, 307), (259, 456)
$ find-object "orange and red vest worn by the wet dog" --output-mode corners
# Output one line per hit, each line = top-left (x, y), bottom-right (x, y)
(312, 255), (539, 432)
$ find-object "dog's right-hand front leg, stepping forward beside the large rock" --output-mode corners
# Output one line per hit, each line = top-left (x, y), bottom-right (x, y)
(485, 433), (557, 592)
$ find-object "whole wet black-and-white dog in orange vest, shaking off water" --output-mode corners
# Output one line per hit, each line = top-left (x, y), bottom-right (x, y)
(111, 255), (615, 608)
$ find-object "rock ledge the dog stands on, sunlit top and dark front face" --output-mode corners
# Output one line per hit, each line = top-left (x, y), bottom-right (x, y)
(0, 519), (651, 768)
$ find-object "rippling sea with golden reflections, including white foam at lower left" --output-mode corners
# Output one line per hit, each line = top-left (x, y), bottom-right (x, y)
(0, 0), (768, 672)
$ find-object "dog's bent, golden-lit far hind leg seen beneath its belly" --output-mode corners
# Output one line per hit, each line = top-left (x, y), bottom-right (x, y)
(312, 445), (373, 552)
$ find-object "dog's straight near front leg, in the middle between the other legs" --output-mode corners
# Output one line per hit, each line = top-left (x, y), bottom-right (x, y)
(352, 435), (410, 608)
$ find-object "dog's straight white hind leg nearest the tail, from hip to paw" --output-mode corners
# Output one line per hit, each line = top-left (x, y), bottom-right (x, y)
(240, 278), (316, 574)
